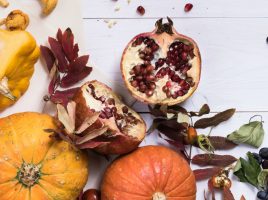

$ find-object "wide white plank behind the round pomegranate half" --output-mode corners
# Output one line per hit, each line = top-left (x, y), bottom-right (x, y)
(84, 18), (268, 111)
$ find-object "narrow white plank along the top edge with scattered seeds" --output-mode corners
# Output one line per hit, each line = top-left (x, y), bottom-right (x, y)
(82, 0), (268, 18)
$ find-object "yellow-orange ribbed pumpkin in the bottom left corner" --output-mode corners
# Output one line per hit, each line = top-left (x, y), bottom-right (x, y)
(0, 113), (88, 200)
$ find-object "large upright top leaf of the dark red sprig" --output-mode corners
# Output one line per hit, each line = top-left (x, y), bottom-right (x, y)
(61, 28), (78, 62)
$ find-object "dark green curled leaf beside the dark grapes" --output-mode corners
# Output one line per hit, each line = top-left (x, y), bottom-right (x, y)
(234, 152), (261, 187)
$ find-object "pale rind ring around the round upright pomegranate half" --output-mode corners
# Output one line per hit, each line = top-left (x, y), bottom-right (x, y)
(120, 27), (201, 105)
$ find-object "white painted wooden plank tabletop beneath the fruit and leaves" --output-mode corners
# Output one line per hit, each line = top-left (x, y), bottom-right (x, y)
(80, 0), (268, 200)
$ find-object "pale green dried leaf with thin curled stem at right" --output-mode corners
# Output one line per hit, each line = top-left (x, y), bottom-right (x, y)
(227, 121), (264, 148)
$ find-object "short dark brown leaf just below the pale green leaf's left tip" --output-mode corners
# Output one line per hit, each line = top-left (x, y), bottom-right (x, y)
(208, 136), (238, 150)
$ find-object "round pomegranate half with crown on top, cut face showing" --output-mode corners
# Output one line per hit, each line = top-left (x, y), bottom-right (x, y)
(121, 18), (201, 105)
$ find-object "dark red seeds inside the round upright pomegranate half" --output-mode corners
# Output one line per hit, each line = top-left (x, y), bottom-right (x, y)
(130, 37), (195, 99)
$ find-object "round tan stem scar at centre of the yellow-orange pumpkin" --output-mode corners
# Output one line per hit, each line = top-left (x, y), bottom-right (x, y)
(17, 163), (41, 187)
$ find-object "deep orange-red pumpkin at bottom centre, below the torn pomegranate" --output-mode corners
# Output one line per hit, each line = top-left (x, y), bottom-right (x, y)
(101, 146), (196, 200)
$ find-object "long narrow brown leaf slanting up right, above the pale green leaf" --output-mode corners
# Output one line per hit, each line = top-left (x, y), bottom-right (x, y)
(194, 109), (235, 128)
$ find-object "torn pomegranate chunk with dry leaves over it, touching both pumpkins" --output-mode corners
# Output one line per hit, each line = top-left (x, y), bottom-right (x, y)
(73, 81), (146, 155)
